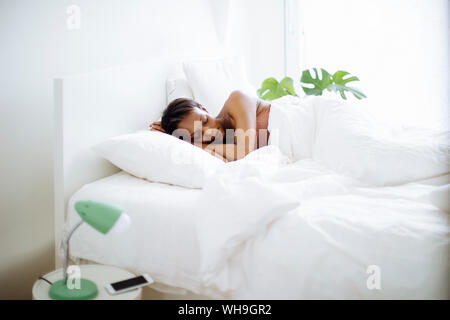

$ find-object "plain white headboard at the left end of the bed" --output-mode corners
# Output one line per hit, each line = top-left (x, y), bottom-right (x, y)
(54, 58), (195, 267)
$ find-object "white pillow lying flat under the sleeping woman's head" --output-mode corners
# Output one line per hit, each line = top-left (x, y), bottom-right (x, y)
(94, 131), (225, 188)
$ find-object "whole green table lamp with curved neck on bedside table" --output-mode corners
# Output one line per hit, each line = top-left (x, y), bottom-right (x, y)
(48, 201), (130, 300)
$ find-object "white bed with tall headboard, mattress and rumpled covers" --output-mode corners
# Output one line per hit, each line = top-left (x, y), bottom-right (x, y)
(55, 58), (450, 299)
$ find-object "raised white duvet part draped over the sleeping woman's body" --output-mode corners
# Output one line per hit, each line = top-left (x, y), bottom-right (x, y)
(269, 96), (450, 186)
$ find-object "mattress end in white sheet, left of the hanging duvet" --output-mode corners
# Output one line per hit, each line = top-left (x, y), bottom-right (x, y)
(66, 171), (211, 293)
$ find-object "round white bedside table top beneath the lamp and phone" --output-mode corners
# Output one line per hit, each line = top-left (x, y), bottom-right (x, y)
(33, 264), (142, 300)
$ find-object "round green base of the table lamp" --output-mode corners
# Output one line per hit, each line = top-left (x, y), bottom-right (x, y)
(48, 279), (98, 300)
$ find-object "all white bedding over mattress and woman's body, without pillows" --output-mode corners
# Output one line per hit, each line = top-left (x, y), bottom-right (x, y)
(68, 99), (450, 299)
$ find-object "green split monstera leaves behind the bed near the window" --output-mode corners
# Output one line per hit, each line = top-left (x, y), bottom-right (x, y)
(257, 68), (366, 100)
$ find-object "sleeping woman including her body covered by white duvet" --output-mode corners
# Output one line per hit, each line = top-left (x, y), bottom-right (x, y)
(150, 91), (450, 186)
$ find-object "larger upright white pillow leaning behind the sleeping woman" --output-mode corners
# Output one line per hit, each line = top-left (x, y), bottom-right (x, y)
(183, 57), (256, 116)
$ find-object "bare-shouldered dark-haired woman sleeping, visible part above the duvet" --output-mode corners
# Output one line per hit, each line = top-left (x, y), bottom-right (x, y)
(150, 91), (270, 161)
